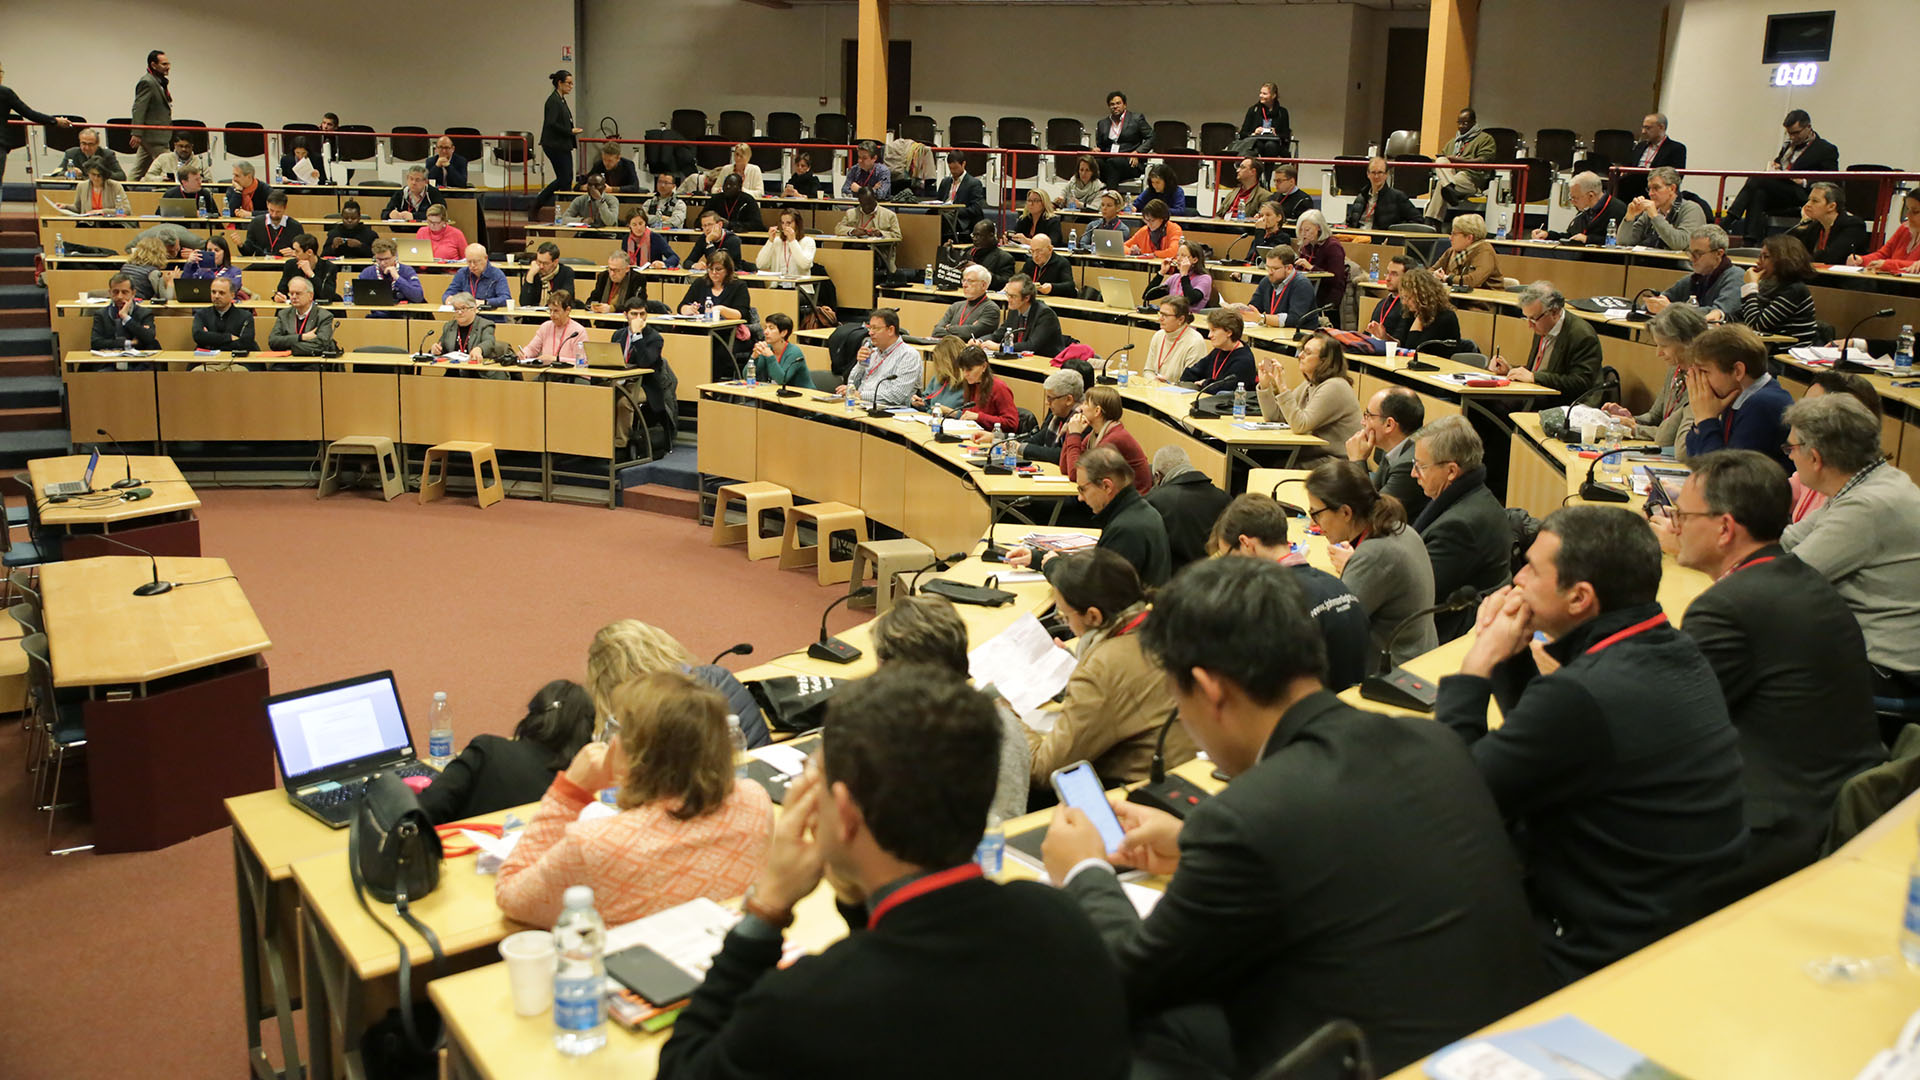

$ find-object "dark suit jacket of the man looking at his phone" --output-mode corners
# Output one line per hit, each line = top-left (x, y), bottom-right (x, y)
(1066, 690), (1548, 1076)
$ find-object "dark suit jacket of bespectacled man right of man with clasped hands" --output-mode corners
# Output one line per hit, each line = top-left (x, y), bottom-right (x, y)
(1682, 544), (1887, 901)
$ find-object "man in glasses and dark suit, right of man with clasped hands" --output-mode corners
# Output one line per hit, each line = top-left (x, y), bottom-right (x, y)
(1655, 450), (1887, 905)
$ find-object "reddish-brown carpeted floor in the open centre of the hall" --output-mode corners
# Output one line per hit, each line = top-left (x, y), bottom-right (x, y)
(0, 490), (866, 1080)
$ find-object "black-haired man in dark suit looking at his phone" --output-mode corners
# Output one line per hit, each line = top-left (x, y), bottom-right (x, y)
(1043, 559), (1544, 1076)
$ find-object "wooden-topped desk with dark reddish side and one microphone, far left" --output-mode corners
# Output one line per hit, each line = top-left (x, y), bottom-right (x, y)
(40, 555), (273, 851)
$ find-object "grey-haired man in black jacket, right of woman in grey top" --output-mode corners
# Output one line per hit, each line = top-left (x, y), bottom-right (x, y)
(1413, 415), (1513, 644)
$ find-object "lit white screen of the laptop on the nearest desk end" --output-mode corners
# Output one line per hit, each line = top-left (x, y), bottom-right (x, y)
(267, 671), (413, 782)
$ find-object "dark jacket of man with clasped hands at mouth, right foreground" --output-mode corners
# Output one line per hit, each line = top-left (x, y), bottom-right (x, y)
(1434, 601), (1747, 982)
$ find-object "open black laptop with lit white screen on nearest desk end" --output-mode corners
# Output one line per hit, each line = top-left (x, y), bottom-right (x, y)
(267, 671), (434, 828)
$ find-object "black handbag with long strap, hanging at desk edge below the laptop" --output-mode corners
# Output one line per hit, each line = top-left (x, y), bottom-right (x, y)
(348, 773), (447, 1076)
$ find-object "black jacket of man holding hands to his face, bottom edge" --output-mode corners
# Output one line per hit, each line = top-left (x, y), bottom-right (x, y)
(660, 868), (1129, 1080)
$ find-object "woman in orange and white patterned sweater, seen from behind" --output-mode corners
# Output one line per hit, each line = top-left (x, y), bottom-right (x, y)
(493, 671), (774, 926)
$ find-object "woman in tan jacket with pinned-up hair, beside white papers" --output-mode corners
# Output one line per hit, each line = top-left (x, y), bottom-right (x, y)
(1027, 550), (1194, 792)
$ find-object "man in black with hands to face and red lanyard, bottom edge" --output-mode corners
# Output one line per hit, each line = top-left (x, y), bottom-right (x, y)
(660, 665), (1127, 1080)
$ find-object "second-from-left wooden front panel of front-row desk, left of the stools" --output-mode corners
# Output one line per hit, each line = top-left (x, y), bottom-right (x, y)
(154, 371), (321, 442)
